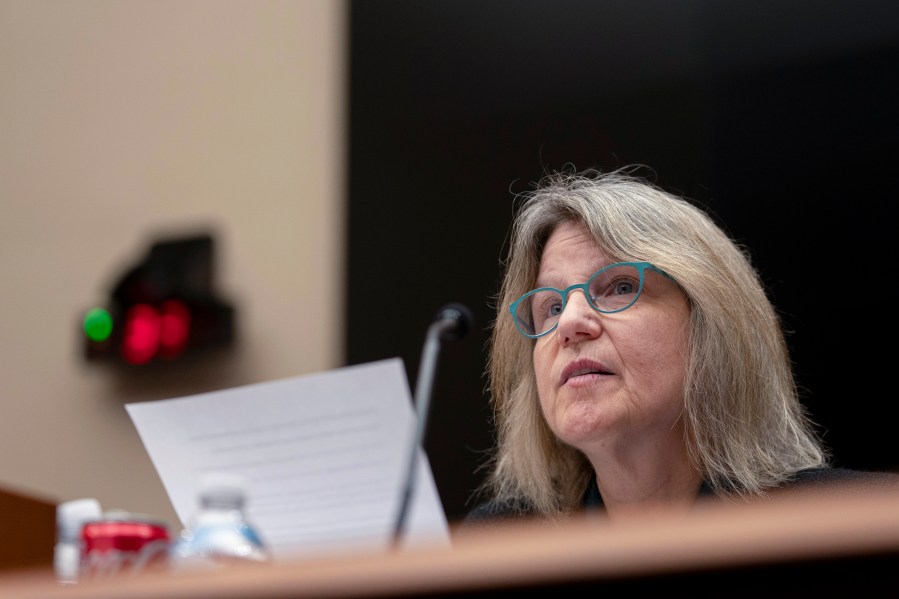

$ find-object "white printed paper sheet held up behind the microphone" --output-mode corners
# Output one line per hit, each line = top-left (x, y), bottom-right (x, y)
(125, 358), (449, 561)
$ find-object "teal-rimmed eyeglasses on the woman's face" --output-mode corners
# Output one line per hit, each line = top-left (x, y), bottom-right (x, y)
(509, 262), (671, 339)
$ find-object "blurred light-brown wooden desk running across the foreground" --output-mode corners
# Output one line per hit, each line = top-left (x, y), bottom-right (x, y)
(0, 489), (899, 599)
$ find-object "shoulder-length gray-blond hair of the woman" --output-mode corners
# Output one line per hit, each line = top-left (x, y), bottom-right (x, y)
(482, 167), (828, 515)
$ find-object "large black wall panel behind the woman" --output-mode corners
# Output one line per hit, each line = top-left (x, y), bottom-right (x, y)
(345, 0), (899, 520)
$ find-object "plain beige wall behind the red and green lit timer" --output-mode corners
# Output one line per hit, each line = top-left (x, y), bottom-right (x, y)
(0, 0), (346, 526)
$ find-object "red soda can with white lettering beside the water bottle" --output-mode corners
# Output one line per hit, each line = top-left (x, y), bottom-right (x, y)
(79, 512), (171, 579)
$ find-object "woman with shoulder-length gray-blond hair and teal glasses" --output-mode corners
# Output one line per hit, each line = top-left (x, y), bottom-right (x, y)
(466, 169), (896, 522)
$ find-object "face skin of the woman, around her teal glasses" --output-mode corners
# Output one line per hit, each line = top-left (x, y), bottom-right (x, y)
(533, 223), (690, 455)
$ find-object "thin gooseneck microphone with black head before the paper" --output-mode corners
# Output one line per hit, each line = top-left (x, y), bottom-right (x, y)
(393, 303), (474, 548)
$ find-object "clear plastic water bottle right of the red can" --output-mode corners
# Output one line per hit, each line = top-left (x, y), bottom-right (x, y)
(170, 473), (271, 570)
